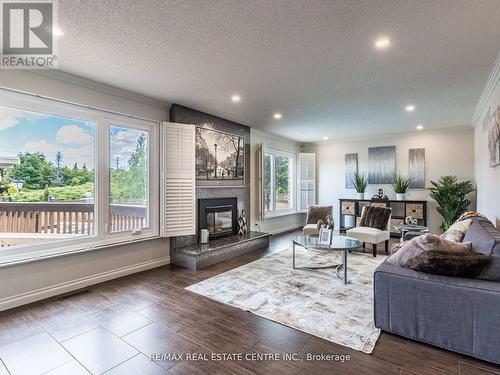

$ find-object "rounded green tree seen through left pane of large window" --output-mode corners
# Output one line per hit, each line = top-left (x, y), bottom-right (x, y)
(7, 152), (53, 190)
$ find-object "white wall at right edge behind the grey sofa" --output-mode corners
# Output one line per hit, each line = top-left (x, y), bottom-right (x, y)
(473, 52), (500, 228)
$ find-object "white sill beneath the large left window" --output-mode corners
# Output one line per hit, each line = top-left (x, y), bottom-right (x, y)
(0, 235), (161, 268)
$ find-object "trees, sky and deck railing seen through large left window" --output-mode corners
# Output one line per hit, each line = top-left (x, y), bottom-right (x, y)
(0, 107), (149, 248)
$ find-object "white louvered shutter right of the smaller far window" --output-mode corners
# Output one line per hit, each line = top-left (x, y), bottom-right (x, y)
(298, 153), (316, 212)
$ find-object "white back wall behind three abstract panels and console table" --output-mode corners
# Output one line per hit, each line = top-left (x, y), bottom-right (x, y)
(304, 127), (474, 233)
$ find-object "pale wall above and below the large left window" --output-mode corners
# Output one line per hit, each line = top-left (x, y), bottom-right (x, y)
(0, 70), (170, 310)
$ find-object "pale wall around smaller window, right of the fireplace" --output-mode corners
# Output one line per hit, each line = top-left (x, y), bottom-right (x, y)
(250, 128), (305, 234)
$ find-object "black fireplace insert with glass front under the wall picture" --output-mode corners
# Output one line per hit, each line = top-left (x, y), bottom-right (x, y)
(198, 198), (238, 239)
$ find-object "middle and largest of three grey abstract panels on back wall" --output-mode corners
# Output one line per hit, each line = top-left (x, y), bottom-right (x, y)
(368, 146), (396, 184)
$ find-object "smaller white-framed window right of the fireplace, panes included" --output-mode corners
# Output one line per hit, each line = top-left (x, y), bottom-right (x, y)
(264, 148), (296, 217)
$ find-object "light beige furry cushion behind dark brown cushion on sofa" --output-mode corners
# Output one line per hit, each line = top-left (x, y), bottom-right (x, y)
(387, 233), (471, 267)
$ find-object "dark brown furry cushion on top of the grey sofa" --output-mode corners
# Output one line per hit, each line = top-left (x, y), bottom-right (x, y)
(408, 250), (491, 278)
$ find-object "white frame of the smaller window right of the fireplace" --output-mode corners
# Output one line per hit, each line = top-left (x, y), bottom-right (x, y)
(262, 147), (297, 219)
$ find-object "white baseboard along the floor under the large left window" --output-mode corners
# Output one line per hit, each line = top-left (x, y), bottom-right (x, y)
(0, 257), (170, 311)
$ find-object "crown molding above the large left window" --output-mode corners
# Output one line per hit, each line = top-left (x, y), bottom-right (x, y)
(29, 70), (171, 110)
